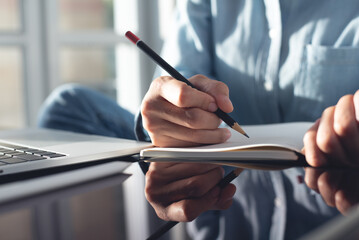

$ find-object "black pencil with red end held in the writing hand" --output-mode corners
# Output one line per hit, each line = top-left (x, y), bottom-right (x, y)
(125, 31), (249, 138)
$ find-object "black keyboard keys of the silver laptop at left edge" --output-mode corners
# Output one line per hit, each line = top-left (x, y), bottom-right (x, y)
(0, 143), (66, 165)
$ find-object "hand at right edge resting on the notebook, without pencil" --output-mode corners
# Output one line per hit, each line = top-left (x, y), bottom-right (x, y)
(304, 92), (359, 167)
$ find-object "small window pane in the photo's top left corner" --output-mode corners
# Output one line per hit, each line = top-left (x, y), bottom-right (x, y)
(0, 0), (20, 31)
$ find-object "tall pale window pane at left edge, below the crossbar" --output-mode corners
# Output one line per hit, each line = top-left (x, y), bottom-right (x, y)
(0, 47), (25, 128)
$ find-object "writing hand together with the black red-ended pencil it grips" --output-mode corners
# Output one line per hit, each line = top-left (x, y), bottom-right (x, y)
(126, 32), (248, 147)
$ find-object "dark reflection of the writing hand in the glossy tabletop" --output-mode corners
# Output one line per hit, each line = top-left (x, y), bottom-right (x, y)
(145, 163), (240, 222)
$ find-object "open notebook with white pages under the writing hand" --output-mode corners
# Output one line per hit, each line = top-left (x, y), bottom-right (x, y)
(141, 122), (313, 169)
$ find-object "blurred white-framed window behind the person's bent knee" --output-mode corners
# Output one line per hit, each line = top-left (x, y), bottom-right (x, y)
(0, 0), (174, 129)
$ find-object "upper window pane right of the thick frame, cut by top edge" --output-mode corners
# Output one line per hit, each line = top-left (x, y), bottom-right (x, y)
(58, 0), (114, 31)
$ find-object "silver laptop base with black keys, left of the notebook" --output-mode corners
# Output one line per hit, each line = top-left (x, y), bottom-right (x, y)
(0, 129), (151, 177)
